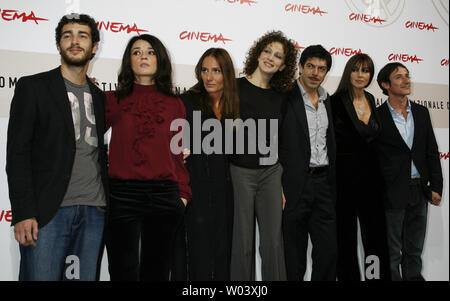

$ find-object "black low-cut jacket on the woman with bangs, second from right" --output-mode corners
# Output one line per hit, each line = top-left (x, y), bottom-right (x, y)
(331, 91), (382, 193)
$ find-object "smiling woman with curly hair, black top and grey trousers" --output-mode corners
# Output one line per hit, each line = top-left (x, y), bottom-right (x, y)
(230, 31), (297, 281)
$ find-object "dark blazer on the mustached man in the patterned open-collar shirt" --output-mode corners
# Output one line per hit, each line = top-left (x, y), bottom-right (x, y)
(279, 85), (336, 211)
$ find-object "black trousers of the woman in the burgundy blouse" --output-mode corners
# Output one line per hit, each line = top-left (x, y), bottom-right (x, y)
(107, 179), (185, 281)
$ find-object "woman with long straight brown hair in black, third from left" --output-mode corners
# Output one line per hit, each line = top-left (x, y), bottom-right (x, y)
(176, 48), (239, 281)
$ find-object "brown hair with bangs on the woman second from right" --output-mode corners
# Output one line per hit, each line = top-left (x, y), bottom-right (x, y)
(335, 53), (375, 96)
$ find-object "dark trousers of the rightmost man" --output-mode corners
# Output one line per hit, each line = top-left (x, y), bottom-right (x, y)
(386, 184), (428, 281)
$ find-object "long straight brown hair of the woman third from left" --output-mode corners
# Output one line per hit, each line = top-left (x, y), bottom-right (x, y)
(188, 48), (239, 119)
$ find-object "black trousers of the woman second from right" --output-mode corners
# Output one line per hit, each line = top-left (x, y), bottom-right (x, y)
(336, 183), (391, 281)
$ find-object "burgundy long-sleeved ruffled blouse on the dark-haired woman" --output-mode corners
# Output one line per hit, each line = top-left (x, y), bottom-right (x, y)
(106, 84), (191, 200)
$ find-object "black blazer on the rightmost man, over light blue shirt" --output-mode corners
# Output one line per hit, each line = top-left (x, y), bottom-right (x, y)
(377, 102), (443, 209)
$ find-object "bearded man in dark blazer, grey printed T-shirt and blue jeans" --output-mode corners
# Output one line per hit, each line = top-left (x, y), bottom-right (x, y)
(6, 14), (107, 280)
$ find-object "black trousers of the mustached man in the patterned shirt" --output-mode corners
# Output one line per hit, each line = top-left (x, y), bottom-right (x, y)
(283, 173), (337, 281)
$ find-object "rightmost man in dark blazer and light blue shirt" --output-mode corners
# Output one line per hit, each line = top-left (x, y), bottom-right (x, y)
(377, 63), (443, 280)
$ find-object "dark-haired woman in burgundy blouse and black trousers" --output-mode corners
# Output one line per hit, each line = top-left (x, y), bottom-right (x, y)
(106, 34), (191, 280)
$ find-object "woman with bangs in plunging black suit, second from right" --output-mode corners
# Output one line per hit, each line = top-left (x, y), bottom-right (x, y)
(331, 54), (389, 281)
